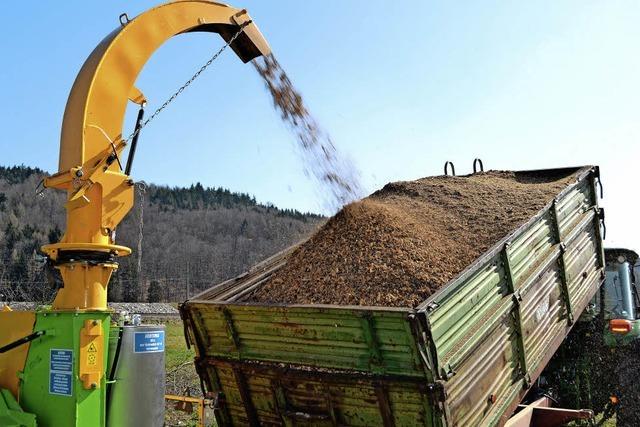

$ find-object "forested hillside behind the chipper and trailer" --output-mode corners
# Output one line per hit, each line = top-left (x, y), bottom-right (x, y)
(0, 166), (322, 302)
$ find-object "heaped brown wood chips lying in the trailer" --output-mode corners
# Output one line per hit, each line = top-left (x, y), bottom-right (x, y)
(251, 171), (575, 307)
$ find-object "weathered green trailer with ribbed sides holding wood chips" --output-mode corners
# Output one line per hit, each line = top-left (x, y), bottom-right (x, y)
(181, 166), (605, 427)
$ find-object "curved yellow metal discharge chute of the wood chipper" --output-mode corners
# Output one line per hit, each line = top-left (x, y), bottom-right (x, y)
(43, 0), (270, 310)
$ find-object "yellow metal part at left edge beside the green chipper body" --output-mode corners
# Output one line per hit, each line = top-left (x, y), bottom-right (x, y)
(0, 309), (36, 400)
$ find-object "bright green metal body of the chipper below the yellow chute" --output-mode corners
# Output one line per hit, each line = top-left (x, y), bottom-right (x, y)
(20, 311), (111, 427)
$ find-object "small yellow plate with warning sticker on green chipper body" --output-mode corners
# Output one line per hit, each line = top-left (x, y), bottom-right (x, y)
(78, 320), (104, 390)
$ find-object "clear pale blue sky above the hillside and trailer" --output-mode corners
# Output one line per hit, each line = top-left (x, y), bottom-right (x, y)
(0, 0), (640, 249)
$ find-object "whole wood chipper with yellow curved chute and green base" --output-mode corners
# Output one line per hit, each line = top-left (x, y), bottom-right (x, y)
(0, 0), (269, 427)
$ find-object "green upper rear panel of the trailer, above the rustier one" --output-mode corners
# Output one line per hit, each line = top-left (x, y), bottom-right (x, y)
(190, 302), (425, 377)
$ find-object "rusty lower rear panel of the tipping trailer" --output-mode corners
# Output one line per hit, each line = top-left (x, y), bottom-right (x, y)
(199, 359), (438, 427)
